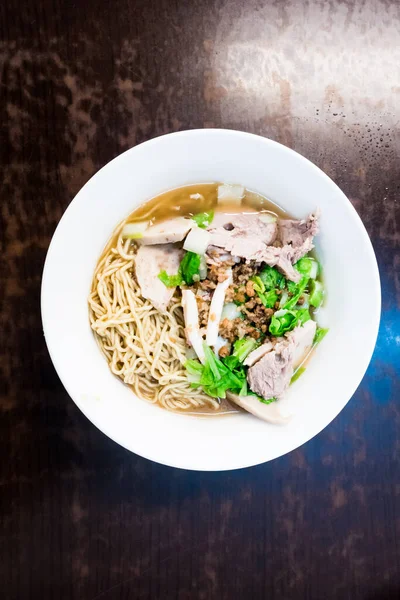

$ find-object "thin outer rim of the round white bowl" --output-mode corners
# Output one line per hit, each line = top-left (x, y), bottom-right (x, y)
(40, 128), (381, 472)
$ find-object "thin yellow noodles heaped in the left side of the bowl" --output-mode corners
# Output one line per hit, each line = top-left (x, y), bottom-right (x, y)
(89, 230), (219, 410)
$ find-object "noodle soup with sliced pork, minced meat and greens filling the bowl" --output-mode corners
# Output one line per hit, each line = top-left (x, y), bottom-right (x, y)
(89, 183), (326, 422)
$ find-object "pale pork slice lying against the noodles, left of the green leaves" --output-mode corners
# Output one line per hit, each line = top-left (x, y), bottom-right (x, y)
(135, 244), (184, 312)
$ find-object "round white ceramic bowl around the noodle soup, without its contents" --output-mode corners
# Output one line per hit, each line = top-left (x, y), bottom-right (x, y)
(42, 129), (380, 471)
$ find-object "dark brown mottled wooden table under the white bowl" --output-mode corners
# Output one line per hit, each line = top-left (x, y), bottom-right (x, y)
(0, 0), (400, 600)
